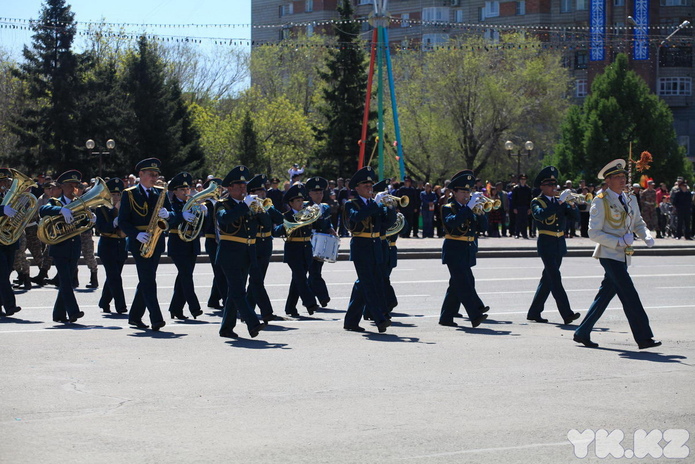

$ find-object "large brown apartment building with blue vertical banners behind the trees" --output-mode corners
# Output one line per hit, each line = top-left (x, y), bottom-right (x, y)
(251, 0), (695, 163)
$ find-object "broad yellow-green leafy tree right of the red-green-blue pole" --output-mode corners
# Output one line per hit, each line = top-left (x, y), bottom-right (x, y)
(394, 34), (569, 181)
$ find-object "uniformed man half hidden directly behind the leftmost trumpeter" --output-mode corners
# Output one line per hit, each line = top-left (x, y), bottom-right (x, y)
(246, 174), (283, 323)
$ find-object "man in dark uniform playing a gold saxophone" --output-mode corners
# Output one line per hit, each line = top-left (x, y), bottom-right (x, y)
(118, 158), (172, 332)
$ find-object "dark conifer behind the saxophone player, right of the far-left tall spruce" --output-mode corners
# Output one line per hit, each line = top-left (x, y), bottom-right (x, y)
(124, 36), (204, 178)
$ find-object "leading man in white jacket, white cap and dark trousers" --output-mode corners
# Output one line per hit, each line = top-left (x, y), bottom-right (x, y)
(574, 159), (661, 349)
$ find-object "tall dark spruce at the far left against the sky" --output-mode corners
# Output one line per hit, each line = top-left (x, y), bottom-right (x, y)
(10, 0), (84, 173)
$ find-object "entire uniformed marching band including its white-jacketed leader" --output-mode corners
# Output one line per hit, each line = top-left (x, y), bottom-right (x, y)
(0, 158), (661, 349)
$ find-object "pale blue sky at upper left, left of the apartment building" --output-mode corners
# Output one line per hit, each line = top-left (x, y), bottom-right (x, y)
(0, 0), (251, 59)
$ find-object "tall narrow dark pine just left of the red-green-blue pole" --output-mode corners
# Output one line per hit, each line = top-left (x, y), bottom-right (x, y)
(313, 0), (374, 177)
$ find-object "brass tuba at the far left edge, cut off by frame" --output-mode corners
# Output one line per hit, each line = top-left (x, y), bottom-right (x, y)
(0, 168), (39, 245)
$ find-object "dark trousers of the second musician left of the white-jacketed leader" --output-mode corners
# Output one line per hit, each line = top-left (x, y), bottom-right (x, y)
(439, 263), (485, 322)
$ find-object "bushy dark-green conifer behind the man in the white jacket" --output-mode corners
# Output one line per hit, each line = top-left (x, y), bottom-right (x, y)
(554, 54), (692, 182)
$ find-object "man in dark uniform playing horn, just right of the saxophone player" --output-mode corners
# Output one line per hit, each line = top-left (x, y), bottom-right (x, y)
(167, 172), (207, 321)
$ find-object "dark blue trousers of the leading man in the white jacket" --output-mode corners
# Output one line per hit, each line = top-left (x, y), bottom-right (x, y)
(575, 258), (654, 343)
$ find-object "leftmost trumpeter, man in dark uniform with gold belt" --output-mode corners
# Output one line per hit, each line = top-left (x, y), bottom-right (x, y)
(215, 166), (265, 338)
